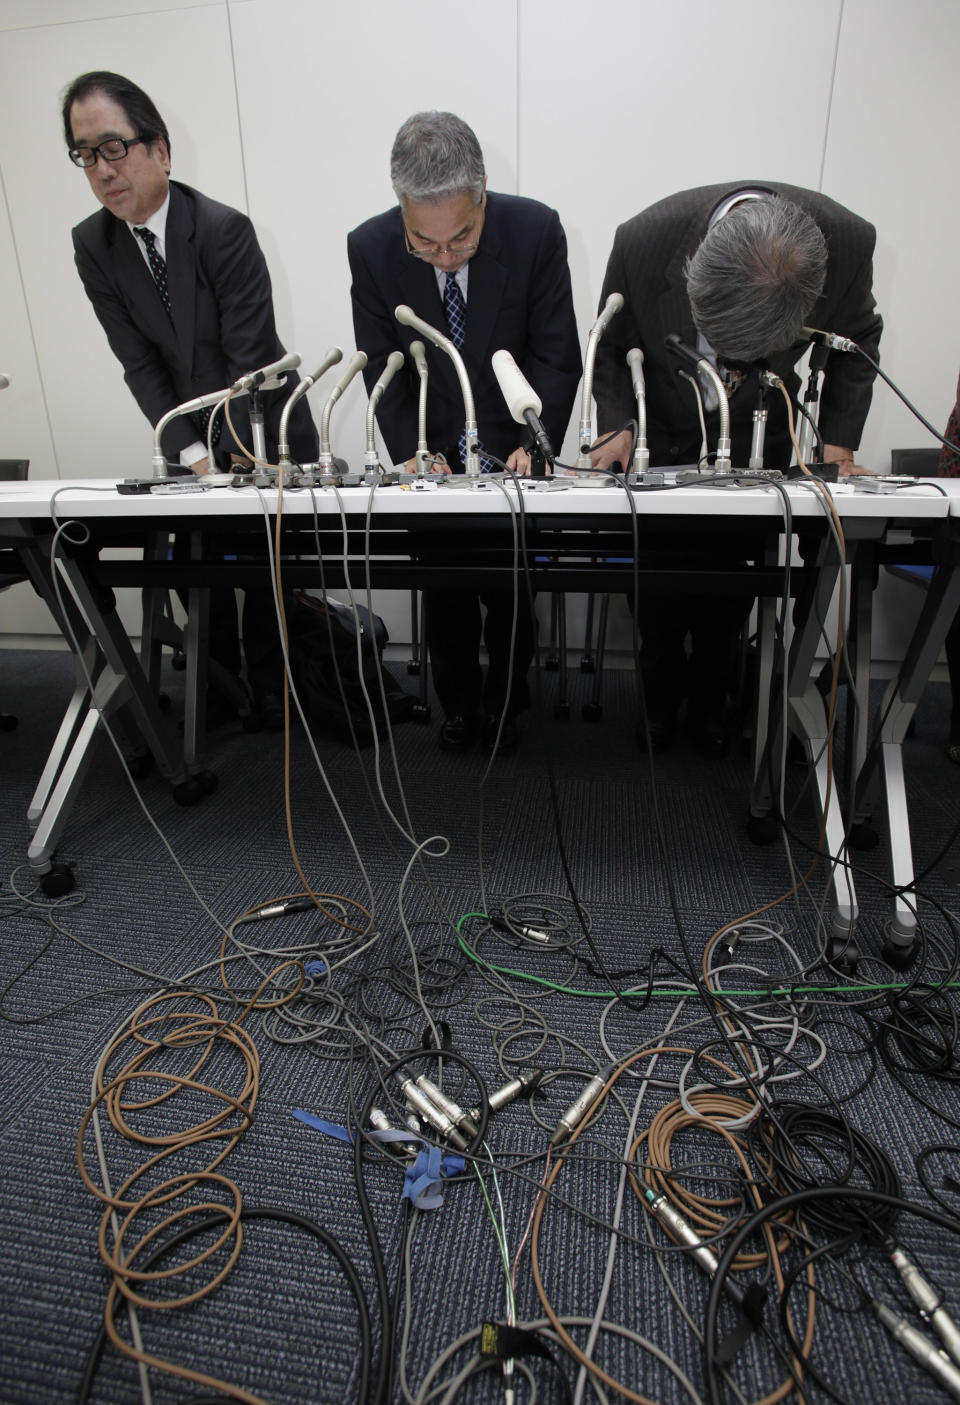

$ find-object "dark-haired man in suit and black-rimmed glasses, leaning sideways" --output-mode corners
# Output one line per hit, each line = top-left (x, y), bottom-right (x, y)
(63, 72), (318, 728)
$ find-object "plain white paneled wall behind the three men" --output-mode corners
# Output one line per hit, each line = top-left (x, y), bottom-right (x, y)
(0, 0), (960, 634)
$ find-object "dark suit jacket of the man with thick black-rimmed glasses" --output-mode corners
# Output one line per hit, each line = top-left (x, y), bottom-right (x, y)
(73, 181), (319, 462)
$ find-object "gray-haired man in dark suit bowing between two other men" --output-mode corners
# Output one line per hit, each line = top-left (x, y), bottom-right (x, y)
(347, 112), (582, 752)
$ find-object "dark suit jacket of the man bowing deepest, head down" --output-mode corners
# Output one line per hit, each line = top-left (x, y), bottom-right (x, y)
(593, 180), (883, 468)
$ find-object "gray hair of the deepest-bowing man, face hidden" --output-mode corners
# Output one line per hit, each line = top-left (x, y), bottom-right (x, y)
(685, 195), (826, 361)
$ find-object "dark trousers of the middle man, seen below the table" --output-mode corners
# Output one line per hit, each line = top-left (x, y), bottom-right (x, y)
(426, 590), (536, 718)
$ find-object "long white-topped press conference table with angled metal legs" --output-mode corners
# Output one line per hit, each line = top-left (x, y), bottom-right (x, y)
(0, 479), (960, 940)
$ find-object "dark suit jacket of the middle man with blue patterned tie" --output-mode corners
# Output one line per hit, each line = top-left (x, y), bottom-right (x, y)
(347, 192), (582, 464)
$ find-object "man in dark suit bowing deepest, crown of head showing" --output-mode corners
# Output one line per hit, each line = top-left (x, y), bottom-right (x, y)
(592, 181), (883, 756)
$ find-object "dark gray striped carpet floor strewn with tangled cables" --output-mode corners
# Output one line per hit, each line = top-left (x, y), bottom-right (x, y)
(0, 651), (960, 1405)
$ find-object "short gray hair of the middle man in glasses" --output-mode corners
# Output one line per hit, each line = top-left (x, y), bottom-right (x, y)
(389, 112), (485, 205)
